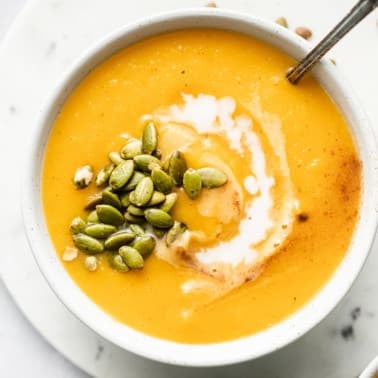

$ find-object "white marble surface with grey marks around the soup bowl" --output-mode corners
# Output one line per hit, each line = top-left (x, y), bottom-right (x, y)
(0, 0), (378, 378)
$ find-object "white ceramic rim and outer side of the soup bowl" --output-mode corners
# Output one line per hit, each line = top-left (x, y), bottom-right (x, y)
(22, 8), (378, 366)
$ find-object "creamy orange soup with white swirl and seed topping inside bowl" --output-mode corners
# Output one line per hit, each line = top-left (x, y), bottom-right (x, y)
(42, 29), (361, 343)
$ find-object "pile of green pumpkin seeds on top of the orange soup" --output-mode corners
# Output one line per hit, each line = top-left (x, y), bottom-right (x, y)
(70, 121), (227, 272)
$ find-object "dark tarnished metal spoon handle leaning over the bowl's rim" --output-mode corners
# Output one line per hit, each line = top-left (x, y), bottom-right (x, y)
(286, 0), (378, 84)
